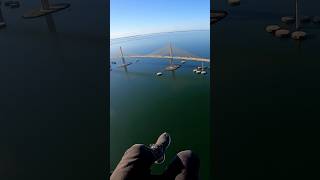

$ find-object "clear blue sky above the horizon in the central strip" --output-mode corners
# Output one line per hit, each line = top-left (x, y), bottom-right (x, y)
(110, 0), (210, 38)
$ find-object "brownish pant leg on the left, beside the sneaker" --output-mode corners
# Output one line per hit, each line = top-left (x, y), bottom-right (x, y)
(110, 144), (155, 180)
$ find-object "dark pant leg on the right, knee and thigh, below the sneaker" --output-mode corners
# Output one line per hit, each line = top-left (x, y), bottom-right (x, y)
(163, 150), (200, 180)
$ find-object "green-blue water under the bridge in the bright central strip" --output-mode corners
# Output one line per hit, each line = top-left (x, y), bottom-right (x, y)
(110, 30), (210, 179)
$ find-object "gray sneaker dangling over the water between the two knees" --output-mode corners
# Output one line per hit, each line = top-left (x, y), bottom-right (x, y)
(150, 132), (171, 164)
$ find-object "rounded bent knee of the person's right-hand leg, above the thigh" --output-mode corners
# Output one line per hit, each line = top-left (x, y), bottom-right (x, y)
(177, 150), (200, 169)
